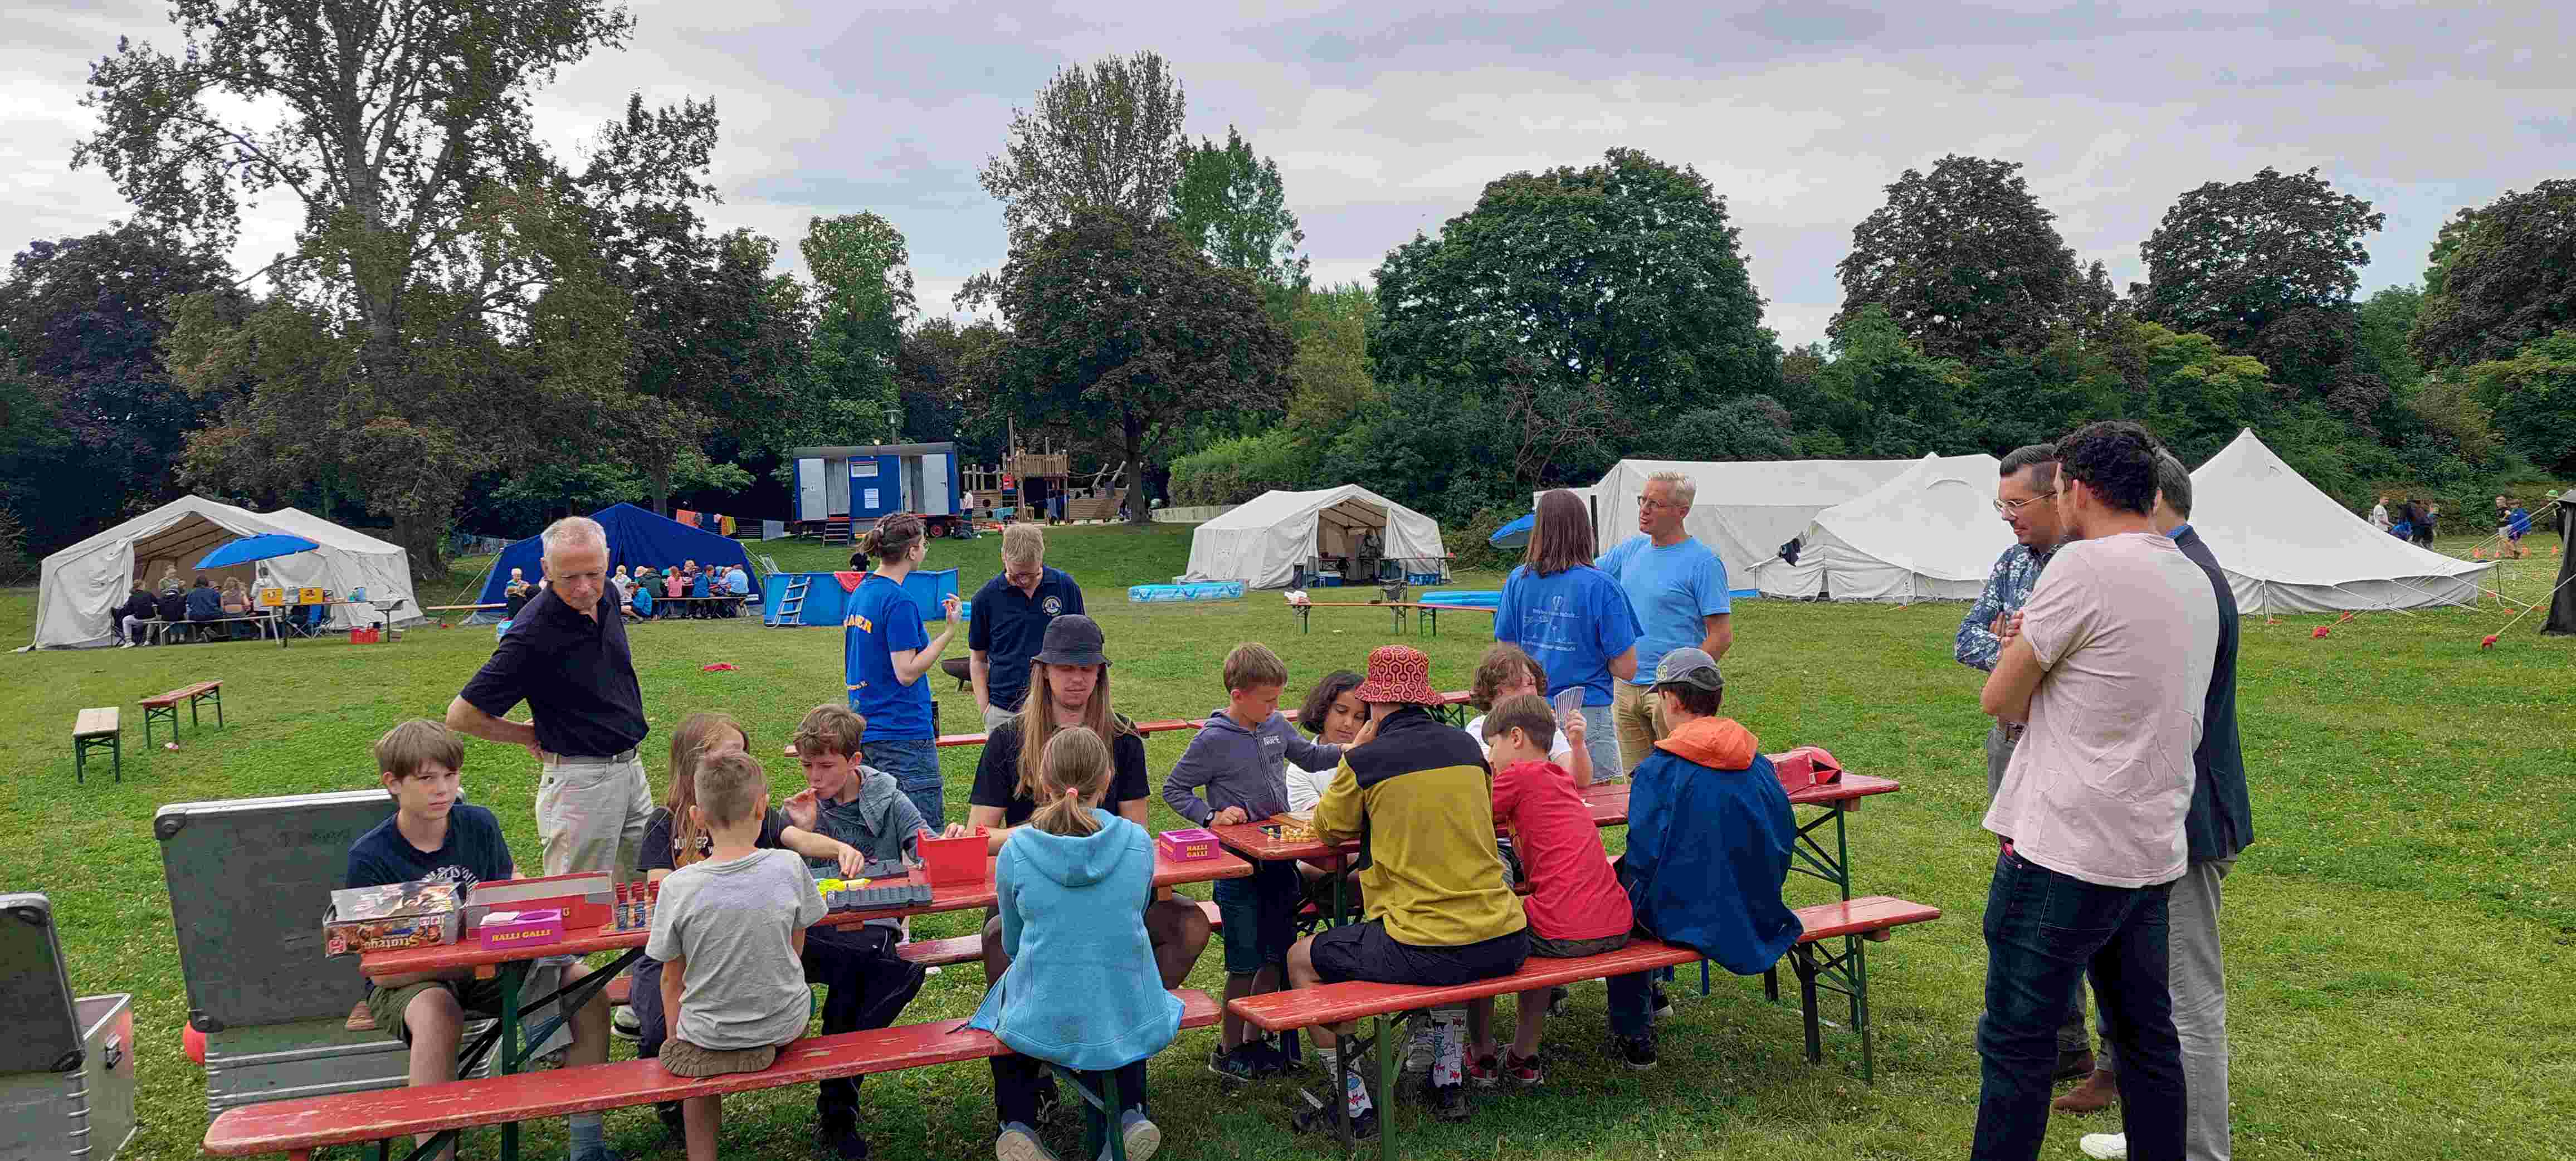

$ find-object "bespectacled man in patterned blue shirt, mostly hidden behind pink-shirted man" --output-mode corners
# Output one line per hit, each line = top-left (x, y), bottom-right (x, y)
(1953, 443), (2094, 1081)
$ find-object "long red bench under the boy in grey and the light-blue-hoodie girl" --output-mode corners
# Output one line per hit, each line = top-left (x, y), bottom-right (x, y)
(206, 988), (1218, 1161)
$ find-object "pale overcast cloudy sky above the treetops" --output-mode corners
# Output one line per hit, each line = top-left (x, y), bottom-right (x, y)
(0, 0), (2576, 343)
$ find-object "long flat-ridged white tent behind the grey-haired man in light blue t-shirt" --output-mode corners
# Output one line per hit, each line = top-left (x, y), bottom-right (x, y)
(1533, 461), (1914, 589)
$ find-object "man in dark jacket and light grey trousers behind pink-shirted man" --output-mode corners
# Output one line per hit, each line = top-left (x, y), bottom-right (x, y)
(2056, 453), (2254, 1161)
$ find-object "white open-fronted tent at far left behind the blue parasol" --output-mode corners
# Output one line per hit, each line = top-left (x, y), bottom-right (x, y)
(36, 497), (420, 648)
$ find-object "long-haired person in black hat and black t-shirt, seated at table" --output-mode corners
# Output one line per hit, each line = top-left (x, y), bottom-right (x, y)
(948, 613), (1208, 988)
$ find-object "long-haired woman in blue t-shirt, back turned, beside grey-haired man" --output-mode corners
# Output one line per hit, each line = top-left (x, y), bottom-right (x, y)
(1494, 489), (1638, 783)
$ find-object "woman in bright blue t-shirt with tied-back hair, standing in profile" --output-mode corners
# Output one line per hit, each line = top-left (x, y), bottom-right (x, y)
(842, 513), (958, 832)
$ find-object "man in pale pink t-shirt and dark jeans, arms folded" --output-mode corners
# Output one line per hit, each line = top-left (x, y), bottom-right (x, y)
(1970, 422), (2218, 1161)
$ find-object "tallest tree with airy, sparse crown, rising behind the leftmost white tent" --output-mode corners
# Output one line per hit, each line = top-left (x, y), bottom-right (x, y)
(72, 0), (714, 567)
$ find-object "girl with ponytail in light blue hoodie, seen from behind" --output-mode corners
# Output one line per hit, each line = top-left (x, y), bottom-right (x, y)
(966, 726), (1180, 1161)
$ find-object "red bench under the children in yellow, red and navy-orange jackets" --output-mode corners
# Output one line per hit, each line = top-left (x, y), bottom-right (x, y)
(1226, 896), (1940, 1158)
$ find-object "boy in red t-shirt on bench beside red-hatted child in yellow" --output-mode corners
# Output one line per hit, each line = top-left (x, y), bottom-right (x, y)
(1466, 695), (1636, 1089)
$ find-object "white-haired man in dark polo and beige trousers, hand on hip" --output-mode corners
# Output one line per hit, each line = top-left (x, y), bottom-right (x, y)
(448, 515), (652, 878)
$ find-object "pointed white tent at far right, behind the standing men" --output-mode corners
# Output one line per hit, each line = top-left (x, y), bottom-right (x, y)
(2192, 430), (2491, 613)
